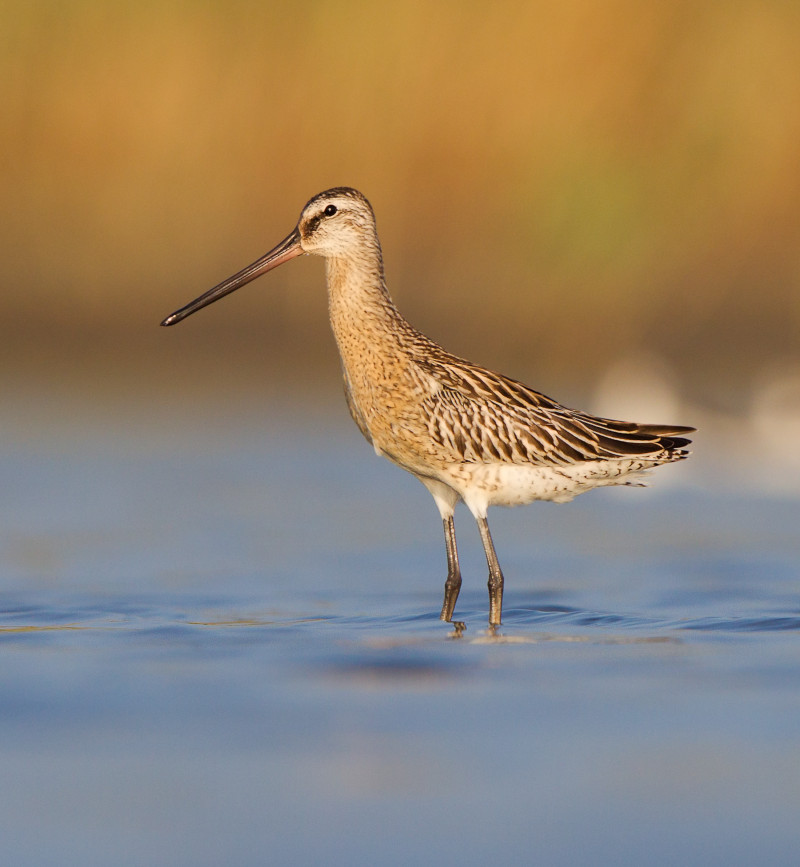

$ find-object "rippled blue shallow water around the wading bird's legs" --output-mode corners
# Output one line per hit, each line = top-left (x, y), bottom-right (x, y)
(0, 390), (800, 865)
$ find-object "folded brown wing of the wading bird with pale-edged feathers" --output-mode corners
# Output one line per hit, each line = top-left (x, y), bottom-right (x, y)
(419, 358), (694, 465)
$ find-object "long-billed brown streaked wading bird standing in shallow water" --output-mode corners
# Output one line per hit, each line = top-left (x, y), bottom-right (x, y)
(161, 187), (694, 626)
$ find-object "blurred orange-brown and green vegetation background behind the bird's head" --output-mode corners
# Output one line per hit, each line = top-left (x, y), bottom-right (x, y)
(0, 0), (800, 401)
